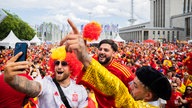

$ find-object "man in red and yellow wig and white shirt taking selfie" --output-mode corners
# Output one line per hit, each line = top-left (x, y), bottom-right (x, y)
(4, 46), (88, 108)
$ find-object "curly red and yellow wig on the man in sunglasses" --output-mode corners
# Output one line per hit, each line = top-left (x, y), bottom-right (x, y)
(49, 46), (83, 78)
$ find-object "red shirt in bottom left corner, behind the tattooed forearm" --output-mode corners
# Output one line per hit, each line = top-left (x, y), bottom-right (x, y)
(0, 74), (32, 108)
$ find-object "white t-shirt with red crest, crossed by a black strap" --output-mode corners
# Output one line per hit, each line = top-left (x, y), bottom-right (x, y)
(36, 76), (88, 108)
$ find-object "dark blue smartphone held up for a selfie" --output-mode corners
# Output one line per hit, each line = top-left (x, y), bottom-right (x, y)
(14, 42), (28, 62)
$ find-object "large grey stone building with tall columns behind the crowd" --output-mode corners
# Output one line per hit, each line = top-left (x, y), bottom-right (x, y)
(119, 0), (192, 42)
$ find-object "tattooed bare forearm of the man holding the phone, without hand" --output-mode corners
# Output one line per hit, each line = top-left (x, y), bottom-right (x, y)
(9, 76), (41, 97)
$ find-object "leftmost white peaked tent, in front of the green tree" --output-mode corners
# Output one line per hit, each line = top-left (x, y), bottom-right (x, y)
(0, 30), (21, 48)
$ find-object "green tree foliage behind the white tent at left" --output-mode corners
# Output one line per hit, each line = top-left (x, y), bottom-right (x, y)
(0, 10), (35, 40)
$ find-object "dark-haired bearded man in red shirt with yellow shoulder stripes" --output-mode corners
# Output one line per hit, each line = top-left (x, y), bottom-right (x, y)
(93, 39), (135, 87)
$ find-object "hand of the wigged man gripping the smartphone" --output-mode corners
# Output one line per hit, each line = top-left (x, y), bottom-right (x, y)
(4, 52), (29, 83)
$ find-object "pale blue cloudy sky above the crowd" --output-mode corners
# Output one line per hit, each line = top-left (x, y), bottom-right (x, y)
(0, 0), (150, 27)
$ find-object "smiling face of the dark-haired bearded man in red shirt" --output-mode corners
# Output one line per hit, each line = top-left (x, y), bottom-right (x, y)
(98, 43), (115, 65)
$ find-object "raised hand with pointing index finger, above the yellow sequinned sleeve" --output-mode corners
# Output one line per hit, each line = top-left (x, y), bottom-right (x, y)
(60, 19), (90, 65)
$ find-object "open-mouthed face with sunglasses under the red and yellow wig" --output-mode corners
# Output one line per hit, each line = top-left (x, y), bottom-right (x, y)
(55, 61), (71, 82)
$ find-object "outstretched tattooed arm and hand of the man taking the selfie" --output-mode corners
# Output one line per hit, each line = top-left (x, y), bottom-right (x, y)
(4, 53), (41, 97)
